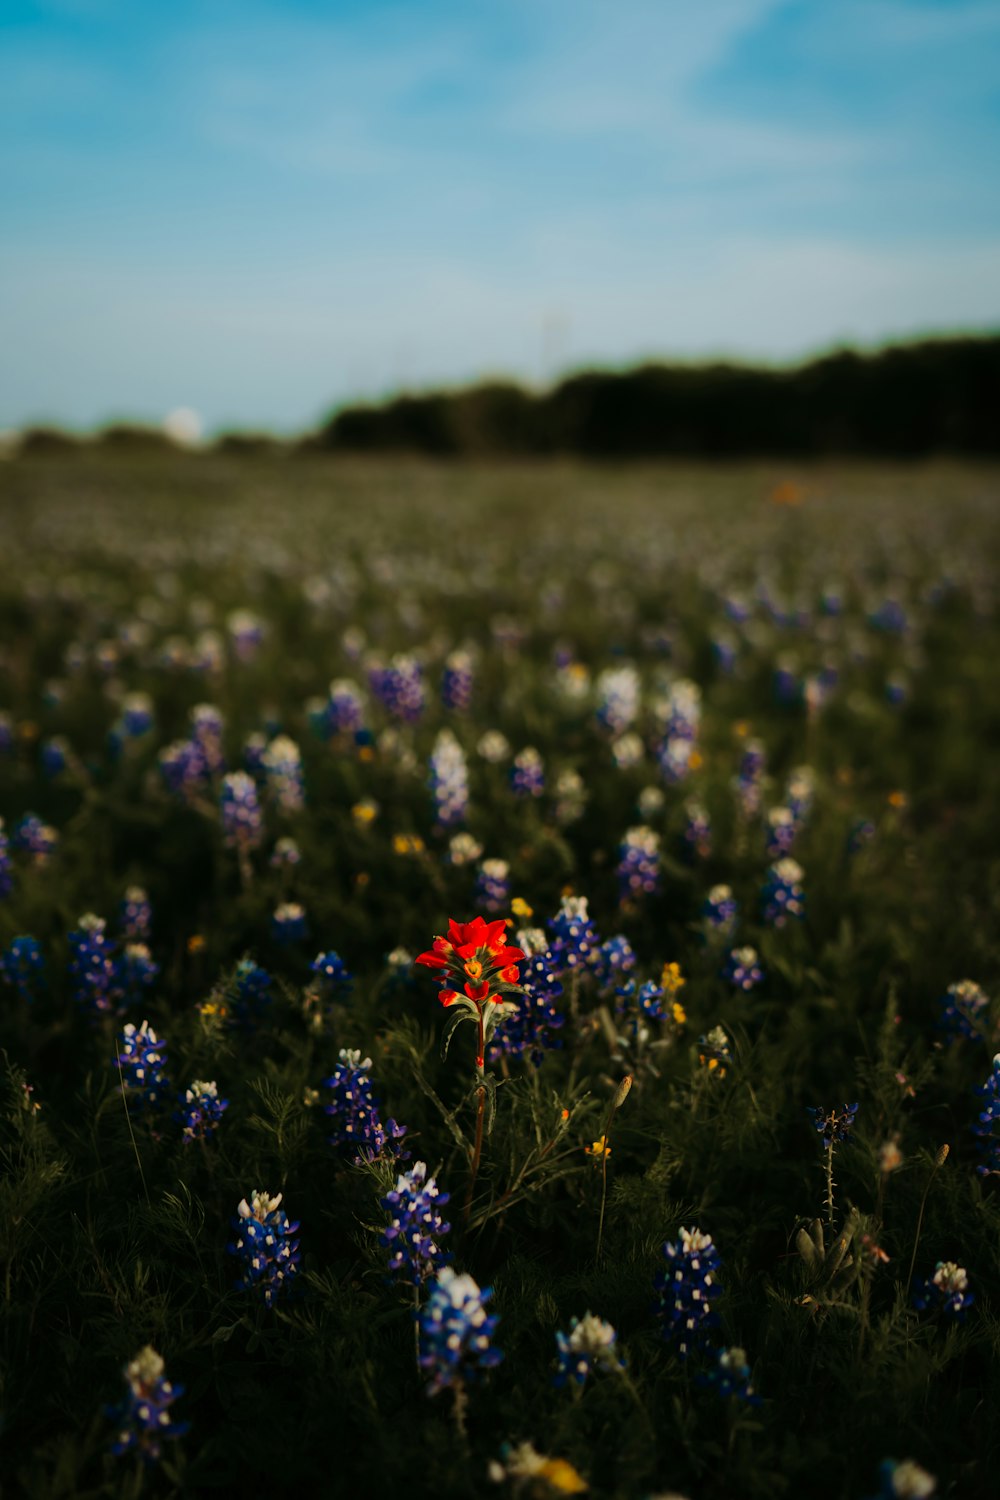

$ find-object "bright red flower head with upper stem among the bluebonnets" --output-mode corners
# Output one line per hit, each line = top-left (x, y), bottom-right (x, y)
(414, 917), (525, 1070)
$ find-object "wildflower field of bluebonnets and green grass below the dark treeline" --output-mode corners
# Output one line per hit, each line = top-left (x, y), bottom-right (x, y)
(0, 453), (1000, 1500)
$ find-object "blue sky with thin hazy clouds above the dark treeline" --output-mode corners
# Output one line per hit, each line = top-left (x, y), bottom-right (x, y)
(0, 0), (1000, 431)
